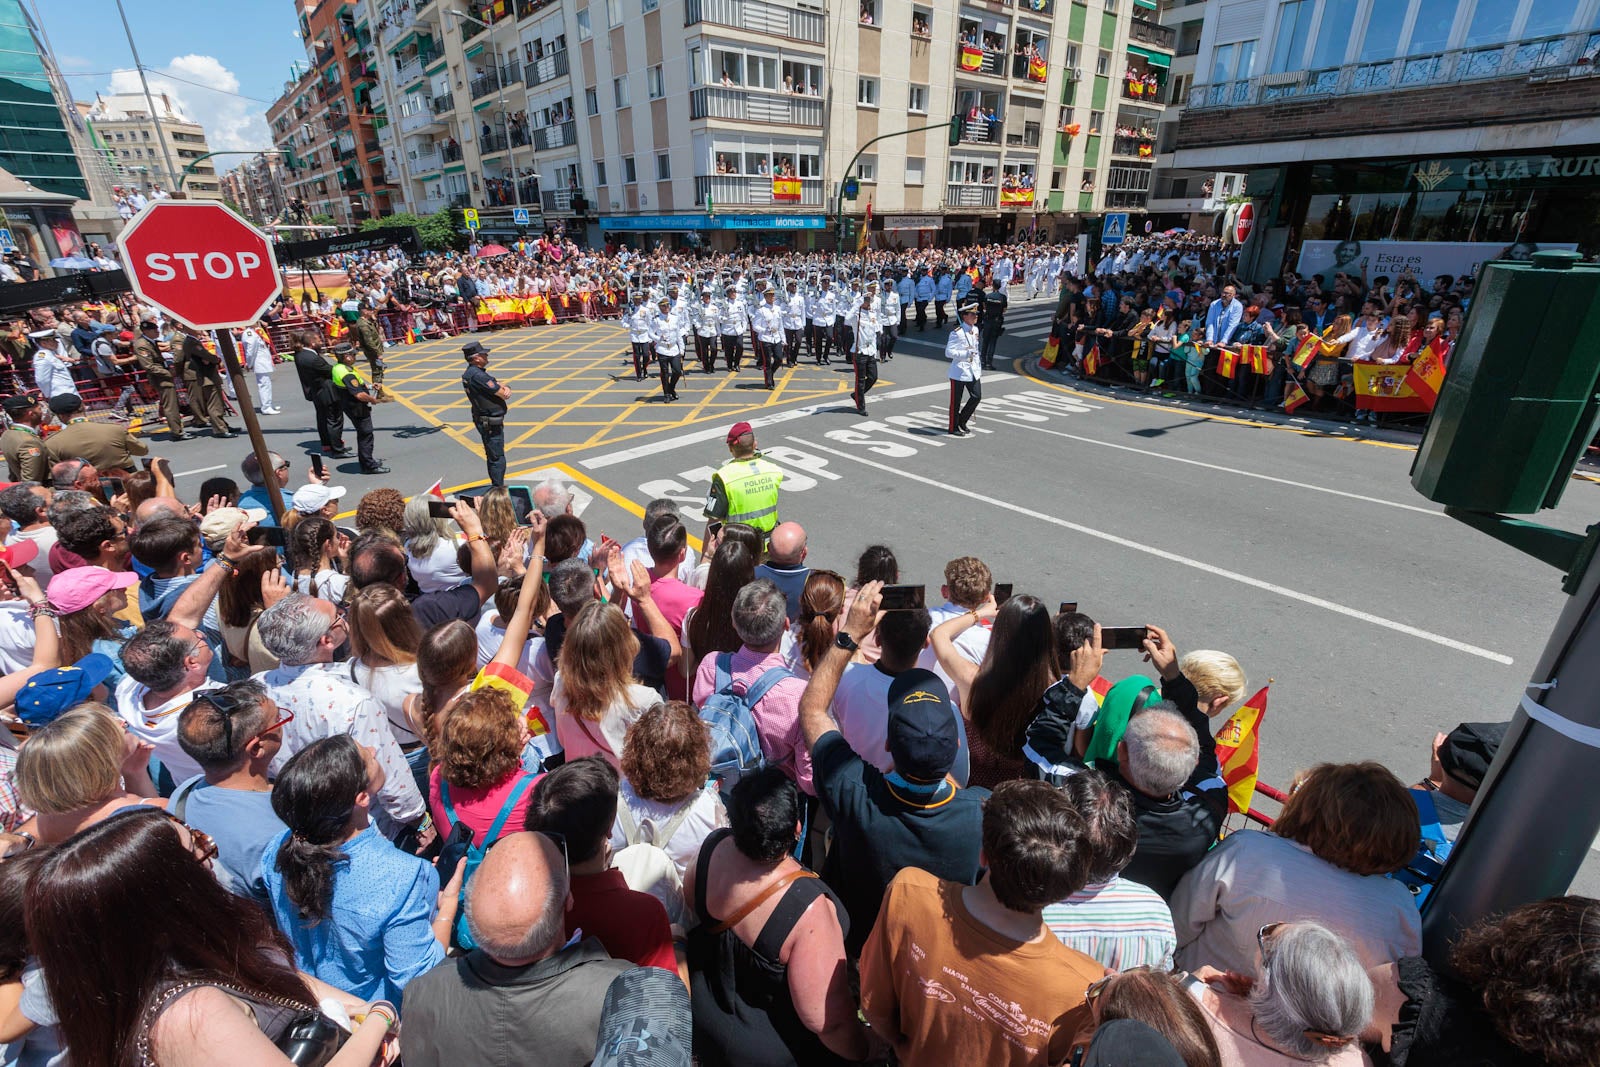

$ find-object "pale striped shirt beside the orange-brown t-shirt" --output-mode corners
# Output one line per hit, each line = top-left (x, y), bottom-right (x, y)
(1045, 877), (1178, 971)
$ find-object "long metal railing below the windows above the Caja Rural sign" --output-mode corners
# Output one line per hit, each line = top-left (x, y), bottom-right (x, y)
(1189, 30), (1600, 110)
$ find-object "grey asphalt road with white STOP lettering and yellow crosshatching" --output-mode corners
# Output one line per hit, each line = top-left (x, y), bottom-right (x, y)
(152, 302), (1600, 894)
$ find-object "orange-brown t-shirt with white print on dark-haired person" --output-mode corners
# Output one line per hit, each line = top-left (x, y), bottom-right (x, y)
(861, 867), (1106, 1067)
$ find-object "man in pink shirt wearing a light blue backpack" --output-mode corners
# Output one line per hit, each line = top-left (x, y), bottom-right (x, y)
(694, 577), (816, 797)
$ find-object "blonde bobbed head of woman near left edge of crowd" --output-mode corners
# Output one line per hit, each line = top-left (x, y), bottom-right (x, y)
(16, 704), (166, 845)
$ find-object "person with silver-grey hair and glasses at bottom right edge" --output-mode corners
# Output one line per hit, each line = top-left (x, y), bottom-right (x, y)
(1190, 923), (1374, 1067)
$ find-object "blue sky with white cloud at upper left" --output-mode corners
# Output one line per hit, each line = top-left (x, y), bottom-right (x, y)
(37, 0), (306, 151)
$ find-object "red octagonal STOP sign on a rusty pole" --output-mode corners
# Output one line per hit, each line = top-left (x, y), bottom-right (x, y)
(117, 200), (278, 330)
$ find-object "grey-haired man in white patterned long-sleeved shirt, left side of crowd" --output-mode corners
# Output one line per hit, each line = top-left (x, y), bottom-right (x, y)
(256, 593), (424, 840)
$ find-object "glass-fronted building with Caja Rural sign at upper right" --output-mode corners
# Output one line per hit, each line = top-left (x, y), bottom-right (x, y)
(1173, 0), (1600, 277)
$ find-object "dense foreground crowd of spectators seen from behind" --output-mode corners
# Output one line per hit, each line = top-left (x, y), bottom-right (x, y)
(0, 435), (1580, 1067)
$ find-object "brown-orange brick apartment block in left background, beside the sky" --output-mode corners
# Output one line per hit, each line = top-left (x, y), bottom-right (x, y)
(267, 0), (395, 227)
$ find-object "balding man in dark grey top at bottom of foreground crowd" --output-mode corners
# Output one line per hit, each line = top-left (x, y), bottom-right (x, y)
(400, 832), (634, 1067)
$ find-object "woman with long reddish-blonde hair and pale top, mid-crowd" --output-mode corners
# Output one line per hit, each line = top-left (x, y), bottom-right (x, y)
(550, 600), (661, 768)
